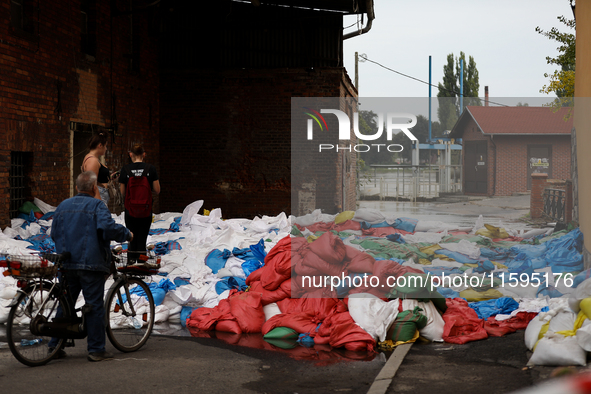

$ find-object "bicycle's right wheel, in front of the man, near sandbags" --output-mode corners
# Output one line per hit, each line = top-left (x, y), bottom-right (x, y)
(105, 278), (155, 353)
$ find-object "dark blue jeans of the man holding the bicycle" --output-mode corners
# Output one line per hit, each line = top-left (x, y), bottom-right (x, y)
(48, 270), (107, 353)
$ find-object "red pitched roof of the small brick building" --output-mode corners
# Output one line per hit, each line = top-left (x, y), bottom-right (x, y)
(450, 106), (573, 137)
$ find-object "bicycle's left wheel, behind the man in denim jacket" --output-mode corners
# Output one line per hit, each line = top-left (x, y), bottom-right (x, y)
(6, 285), (70, 367)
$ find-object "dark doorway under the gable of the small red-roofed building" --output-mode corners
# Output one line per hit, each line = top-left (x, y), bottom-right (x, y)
(464, 141), (488, 194)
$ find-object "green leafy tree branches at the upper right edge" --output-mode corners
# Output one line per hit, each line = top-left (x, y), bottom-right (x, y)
(536, 13), (576, 107)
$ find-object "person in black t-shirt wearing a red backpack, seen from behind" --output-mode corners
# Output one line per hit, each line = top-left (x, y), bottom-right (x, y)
(119, 144), (160, 264)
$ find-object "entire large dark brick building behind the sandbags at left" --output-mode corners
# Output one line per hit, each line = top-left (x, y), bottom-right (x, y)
(0, 0), (373, 227)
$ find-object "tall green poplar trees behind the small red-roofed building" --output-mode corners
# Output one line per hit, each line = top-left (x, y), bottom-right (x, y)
(437, 52), (482, 130)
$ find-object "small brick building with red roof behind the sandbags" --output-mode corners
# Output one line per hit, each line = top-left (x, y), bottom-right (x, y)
(450, 106), (573, 196)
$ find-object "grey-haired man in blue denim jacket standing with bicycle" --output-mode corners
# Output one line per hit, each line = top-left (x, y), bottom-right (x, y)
(49, 171), (133, 361)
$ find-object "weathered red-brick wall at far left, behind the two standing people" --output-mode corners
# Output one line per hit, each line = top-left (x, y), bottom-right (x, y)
(0, 0), (159, 227)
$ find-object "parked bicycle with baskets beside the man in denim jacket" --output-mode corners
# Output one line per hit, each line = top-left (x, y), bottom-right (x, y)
(0, 250), (160, 367)
